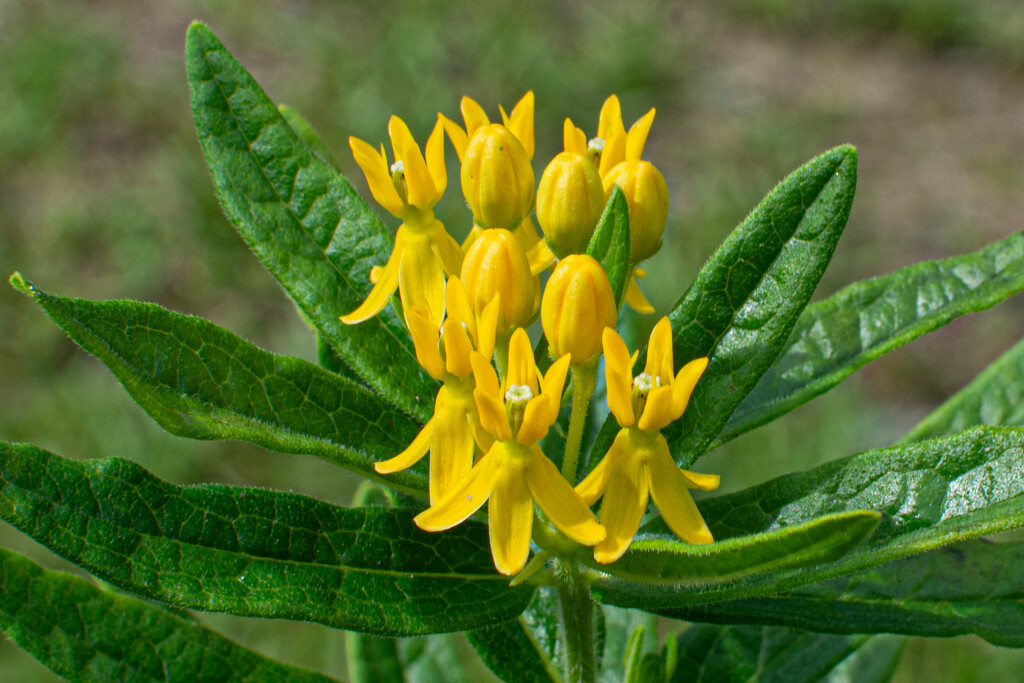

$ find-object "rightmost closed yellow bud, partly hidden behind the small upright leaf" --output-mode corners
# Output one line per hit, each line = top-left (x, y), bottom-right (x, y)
(604, 161), (669, 265)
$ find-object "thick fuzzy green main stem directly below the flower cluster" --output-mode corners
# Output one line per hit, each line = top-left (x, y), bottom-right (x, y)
(555, 559), (596, 683)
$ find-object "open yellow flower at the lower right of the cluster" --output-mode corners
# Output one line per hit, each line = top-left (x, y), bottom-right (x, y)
(577, 317), (719, 563)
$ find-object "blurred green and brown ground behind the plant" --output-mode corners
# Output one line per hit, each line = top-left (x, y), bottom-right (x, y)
(0, 0), (1024, 681)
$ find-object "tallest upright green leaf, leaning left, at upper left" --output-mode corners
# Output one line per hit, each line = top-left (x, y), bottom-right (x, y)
(185, 23), (437, 422)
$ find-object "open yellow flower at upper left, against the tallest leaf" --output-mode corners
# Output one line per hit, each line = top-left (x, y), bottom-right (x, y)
(341, 116), (462, 326)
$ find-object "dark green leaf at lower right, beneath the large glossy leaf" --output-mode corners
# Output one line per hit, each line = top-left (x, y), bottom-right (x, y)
(659, 541), (1024, 647)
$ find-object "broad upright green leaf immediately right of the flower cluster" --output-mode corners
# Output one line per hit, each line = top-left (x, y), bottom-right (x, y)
(663, 145), (857, 467)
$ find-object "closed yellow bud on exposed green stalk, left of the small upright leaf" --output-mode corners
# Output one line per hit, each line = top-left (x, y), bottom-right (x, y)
(541, 254), (616, 365)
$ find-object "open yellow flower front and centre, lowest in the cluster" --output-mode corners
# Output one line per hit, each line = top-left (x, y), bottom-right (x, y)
(416, 329), (604, 575)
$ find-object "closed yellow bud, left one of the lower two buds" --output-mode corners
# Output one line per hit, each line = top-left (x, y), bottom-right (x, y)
(460, 228), (535, 335)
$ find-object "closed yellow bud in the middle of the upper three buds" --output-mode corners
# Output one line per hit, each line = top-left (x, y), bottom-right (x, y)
(537, 152), (604, 256)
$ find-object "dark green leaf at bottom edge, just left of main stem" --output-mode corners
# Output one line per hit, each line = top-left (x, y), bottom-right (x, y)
(465, 614), (560, 683)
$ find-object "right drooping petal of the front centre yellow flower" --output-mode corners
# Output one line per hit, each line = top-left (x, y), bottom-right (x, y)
(526, 446), (605, 546)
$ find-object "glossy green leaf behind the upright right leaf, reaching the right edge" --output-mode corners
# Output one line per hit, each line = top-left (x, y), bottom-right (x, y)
(718, 232), (1024, 443)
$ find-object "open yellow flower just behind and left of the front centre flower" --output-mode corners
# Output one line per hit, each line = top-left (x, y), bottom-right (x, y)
(374, 278), (498, 503)
